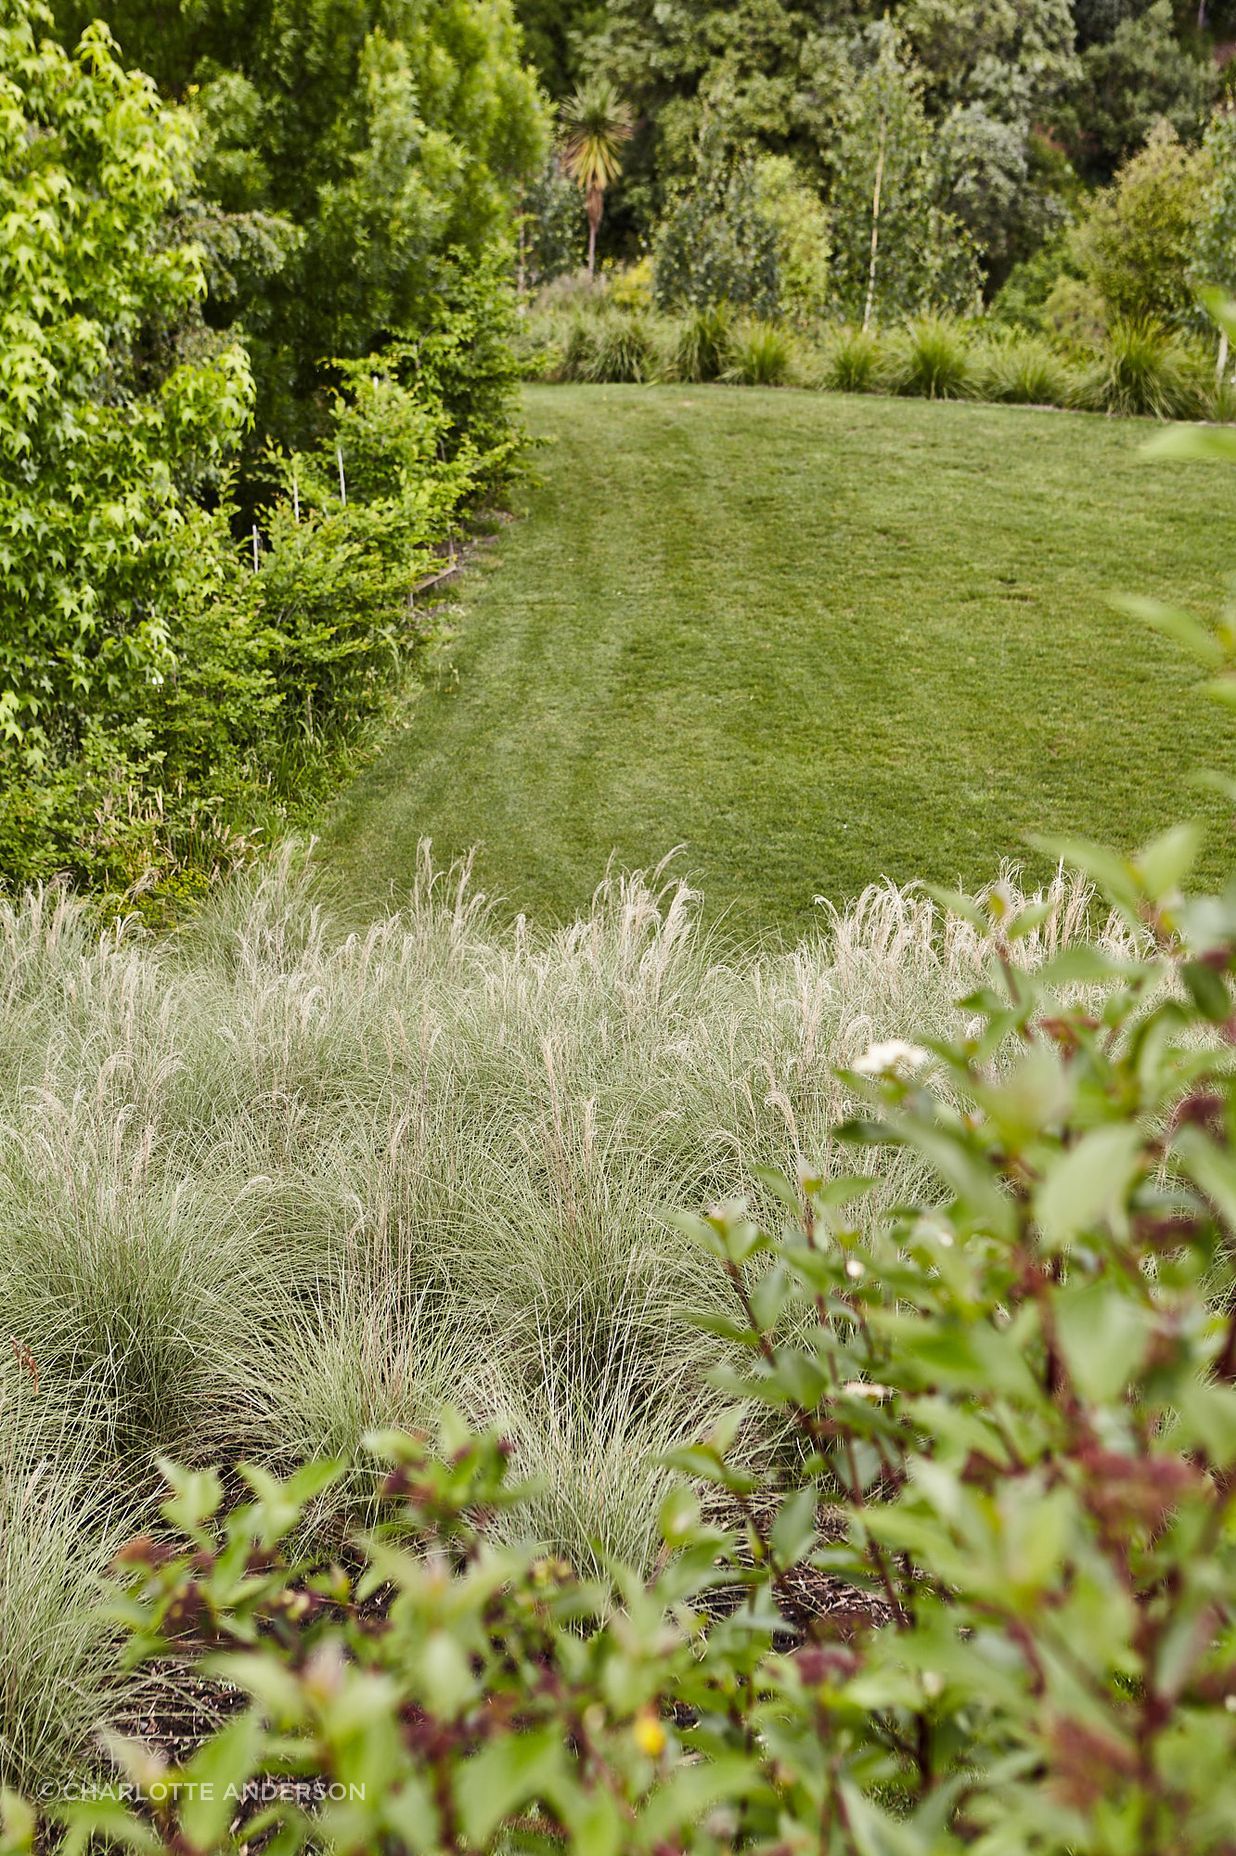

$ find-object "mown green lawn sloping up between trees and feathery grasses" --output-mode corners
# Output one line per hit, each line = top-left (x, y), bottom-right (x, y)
(315, 386), (1236, 934)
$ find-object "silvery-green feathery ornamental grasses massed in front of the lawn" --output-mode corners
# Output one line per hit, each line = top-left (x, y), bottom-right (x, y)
(0, 846), (1114, 1784)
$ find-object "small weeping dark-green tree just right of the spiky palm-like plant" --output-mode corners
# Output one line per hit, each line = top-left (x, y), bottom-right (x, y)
(655, 135), (781, 316)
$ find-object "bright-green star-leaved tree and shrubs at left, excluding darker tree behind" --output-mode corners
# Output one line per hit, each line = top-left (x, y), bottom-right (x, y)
(0, 0), (530, 911)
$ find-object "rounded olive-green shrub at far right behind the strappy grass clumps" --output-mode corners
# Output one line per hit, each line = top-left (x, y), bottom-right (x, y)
(1073, 122), (1210, 325)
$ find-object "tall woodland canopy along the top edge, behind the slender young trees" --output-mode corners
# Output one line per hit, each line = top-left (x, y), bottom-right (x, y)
(518, 0), (1236, 295)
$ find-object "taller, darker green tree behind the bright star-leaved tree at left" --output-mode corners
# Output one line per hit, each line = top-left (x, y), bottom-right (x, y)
(56, 0), (546, 444)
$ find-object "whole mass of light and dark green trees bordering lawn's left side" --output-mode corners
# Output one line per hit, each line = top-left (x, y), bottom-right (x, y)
(0, 0), (546, 896)
